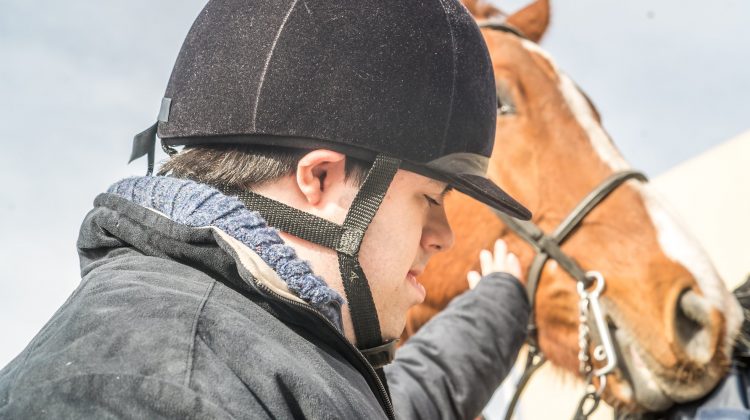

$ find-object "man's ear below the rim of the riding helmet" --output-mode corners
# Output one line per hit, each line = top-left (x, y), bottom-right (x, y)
(297, 149), (346, 206)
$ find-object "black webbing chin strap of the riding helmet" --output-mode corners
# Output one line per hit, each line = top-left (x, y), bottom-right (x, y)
(222, 155), (401, 370)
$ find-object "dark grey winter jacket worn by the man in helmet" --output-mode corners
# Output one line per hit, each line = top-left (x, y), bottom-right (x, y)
(0, 194), (529, 419)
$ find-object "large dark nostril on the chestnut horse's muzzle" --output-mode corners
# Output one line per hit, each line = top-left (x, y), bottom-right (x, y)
(674, 289), (716, 363)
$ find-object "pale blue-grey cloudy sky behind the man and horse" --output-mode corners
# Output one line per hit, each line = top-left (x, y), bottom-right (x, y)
(0, 0), (750, 367)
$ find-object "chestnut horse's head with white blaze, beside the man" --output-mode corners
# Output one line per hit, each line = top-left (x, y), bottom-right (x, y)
(405, 0), (742, 412)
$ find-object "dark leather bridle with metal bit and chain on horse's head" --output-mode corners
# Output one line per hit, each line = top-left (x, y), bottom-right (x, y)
(477, 20), (648, 420)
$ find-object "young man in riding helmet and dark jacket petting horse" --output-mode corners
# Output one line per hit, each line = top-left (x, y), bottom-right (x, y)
(0, 0), (530, 419)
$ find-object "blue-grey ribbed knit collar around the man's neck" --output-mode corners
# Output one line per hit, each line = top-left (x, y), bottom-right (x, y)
(107, 176), (344, 331)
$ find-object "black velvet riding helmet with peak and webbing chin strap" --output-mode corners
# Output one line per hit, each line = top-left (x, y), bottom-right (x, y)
(132, 0), (531, 372)
